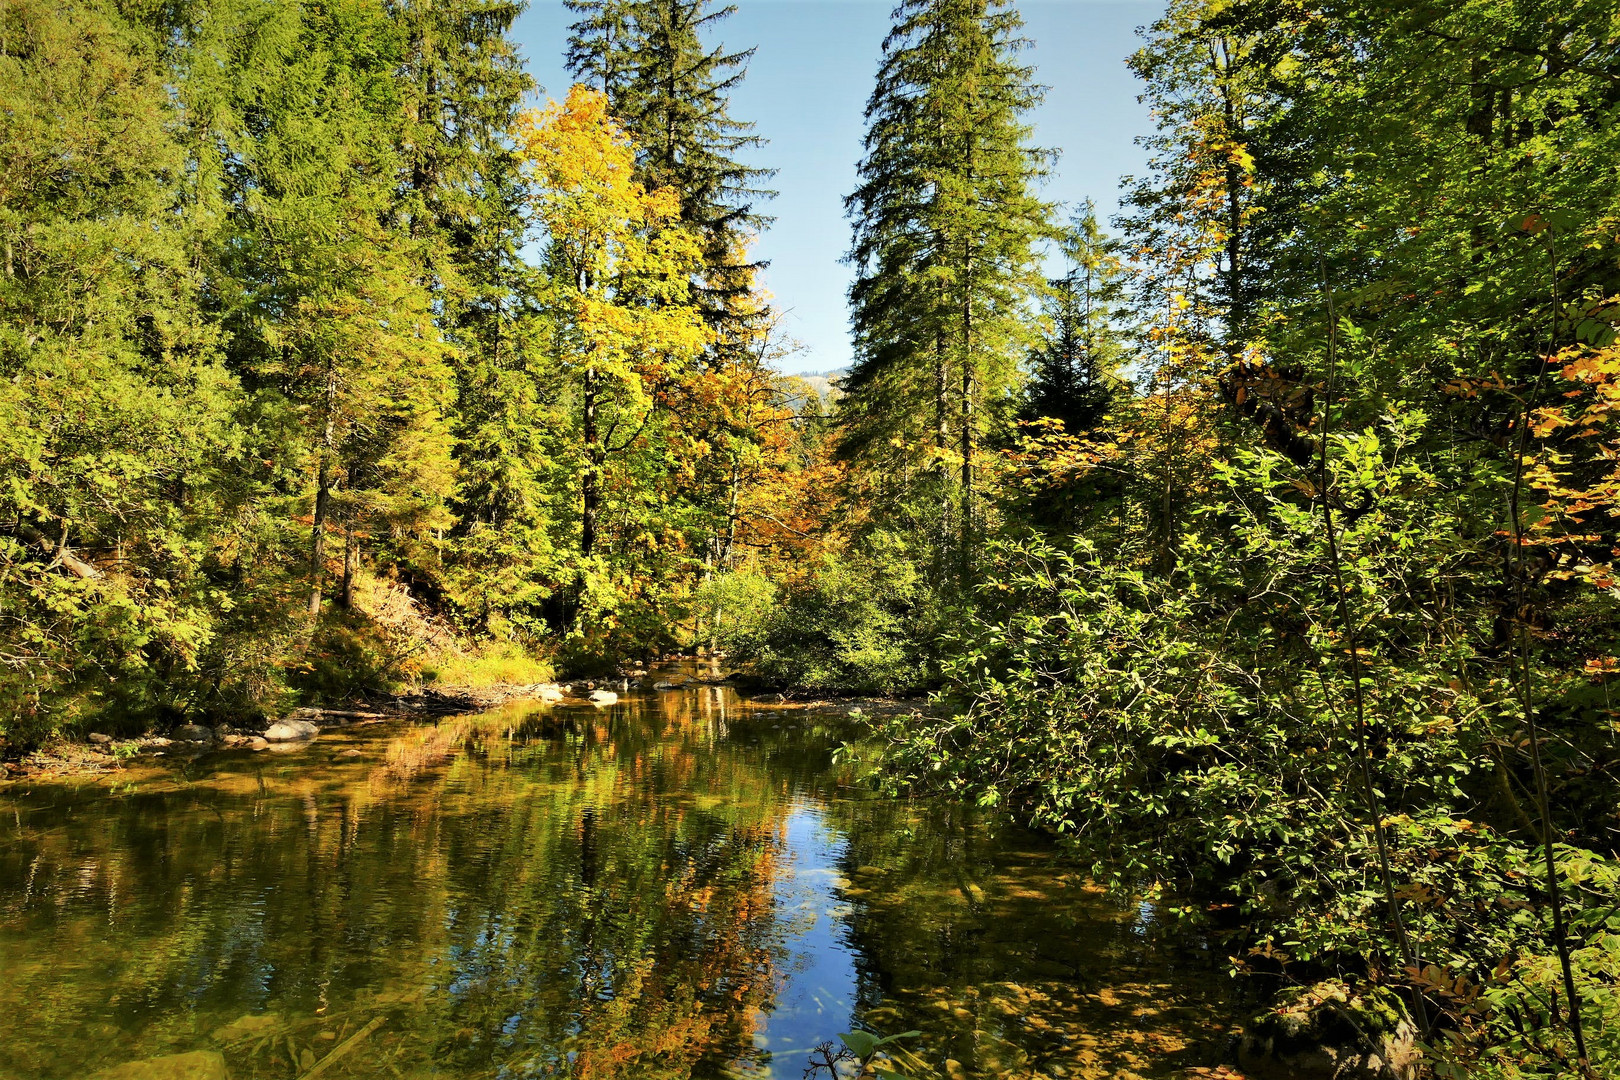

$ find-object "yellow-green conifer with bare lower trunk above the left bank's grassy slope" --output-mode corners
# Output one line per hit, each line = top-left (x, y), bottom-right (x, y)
(227, 3), (452, 615)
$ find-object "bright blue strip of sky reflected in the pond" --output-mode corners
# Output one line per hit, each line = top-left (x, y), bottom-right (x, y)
(755, 798), (855, 1078)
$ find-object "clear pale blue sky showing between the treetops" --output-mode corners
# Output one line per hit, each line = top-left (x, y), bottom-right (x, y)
(517, 0), (1163, 371)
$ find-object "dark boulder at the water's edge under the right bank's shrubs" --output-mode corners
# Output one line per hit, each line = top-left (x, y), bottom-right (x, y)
(1238, 980), (1419, 1080)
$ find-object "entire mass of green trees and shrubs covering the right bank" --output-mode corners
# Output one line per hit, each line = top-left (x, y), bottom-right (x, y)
(886, 0), (1620, 1077)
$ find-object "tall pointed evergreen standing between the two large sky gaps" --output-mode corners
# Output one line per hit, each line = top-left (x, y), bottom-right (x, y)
(844, 0), (1056, 580)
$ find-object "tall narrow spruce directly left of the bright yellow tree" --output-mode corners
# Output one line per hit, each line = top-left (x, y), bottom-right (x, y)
(394, 0), (549, 631)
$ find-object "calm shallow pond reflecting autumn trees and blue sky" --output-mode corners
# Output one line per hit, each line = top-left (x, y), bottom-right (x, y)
(0, 667), (1225, 1080)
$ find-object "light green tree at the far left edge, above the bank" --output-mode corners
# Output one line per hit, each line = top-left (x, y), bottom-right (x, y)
(0, 0), (240, 725)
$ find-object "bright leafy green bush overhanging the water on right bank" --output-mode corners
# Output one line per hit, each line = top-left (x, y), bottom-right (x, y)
(885, 416), (1620, 1061)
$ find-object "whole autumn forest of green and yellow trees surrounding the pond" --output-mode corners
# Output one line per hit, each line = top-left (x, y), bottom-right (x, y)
(0, 0), (1620, 1078)
